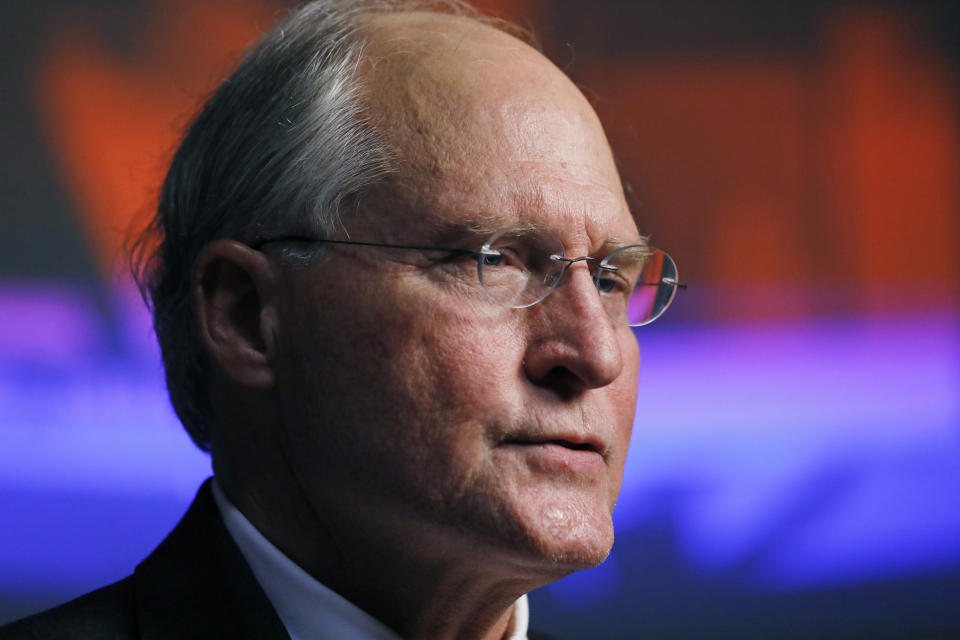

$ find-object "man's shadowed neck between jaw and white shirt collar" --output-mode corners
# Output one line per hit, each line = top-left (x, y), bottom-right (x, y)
(215, 465), (546, 640)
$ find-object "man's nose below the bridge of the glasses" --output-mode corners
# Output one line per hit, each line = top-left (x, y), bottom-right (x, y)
(523, 264), (632, 398)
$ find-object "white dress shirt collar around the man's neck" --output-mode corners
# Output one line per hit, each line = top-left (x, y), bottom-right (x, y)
(212, 479), (530, 640)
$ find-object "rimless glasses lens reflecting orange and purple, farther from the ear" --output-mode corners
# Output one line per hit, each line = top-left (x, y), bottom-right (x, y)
(595, 245), (677, 327)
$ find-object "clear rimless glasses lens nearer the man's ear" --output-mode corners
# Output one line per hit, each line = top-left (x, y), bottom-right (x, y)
(477, 228), (564, 309)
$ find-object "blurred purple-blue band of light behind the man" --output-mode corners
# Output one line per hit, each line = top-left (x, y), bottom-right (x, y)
(0, 282), (960, 636)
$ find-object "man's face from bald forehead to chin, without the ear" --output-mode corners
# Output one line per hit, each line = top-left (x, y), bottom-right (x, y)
(277, 17), (639, 572)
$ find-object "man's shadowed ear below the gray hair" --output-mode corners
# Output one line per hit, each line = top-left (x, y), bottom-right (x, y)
(193, 239), (278, 388)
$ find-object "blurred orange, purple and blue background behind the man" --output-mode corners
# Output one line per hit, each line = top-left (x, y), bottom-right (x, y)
(0, 0), (960, 638)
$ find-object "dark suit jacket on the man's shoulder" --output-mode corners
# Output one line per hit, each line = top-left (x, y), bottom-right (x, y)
(0, 480), (556, 640)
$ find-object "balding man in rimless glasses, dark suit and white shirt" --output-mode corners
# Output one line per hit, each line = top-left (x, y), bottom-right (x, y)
(0, 0), (677, 640)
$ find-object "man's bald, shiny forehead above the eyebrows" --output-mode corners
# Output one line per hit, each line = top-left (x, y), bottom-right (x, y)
(364, 14), (638, 247)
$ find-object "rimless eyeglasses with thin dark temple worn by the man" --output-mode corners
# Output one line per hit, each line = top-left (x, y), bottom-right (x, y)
(251, 227), (687, 327)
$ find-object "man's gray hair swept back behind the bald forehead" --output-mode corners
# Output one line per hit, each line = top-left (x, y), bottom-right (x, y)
(132, 0), (524, 451)
